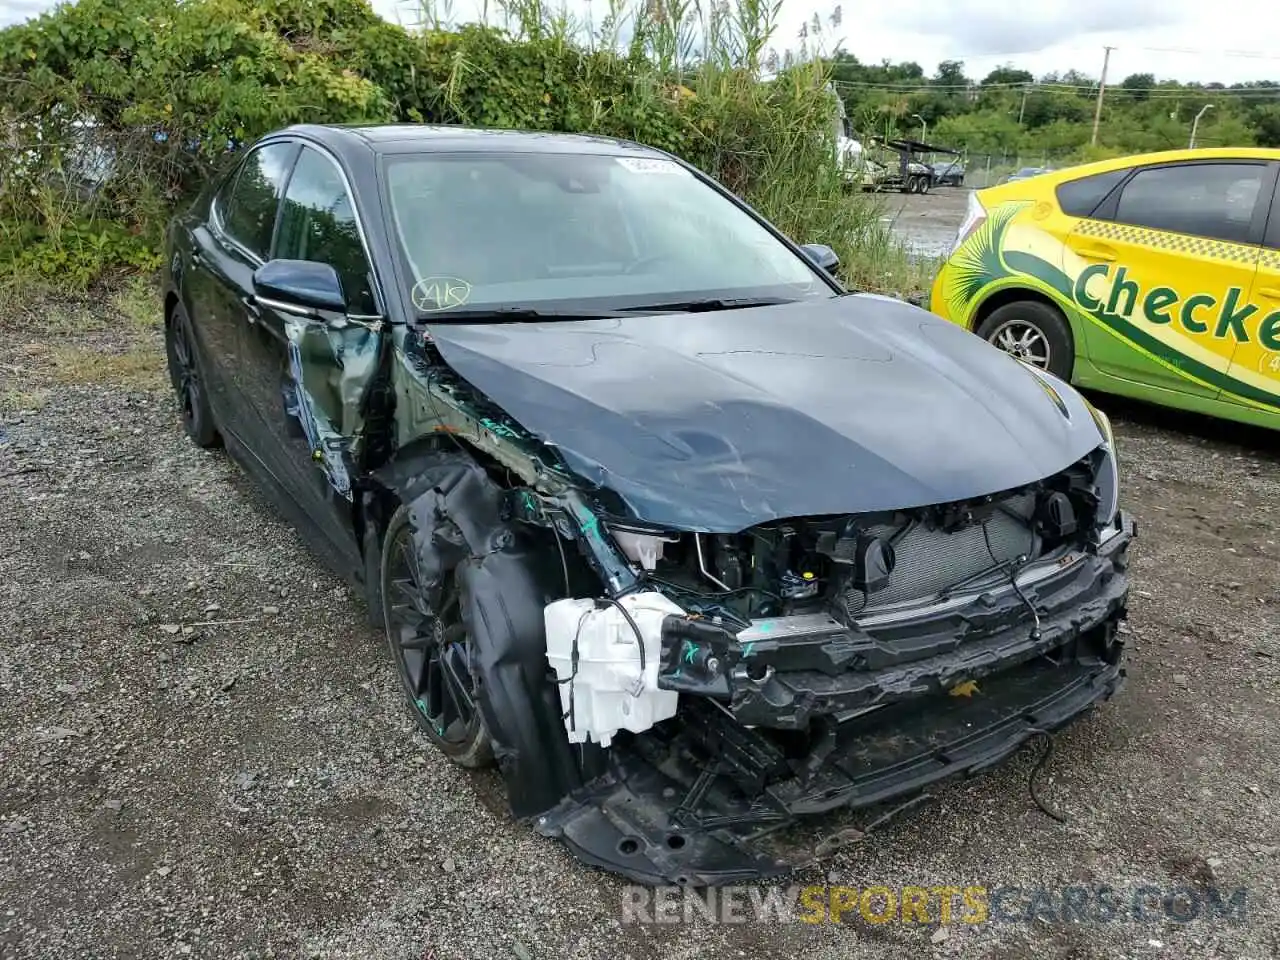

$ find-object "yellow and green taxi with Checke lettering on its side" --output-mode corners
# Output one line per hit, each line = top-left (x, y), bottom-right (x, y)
(929, 148), (1280, 429)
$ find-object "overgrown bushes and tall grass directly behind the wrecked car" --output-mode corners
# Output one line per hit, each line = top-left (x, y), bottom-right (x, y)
(0, 0), (908, 296)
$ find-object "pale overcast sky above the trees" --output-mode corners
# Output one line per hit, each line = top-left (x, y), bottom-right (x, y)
(0, 0), (1280, 83)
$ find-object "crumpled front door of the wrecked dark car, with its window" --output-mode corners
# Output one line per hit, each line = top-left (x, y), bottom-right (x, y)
(241, 138), (383, 561)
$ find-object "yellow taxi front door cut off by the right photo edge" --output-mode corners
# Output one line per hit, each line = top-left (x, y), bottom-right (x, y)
(1222, 175), (1280, 417)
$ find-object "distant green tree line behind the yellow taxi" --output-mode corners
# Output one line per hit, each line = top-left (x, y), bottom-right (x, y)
(831, 54), (1280, 164)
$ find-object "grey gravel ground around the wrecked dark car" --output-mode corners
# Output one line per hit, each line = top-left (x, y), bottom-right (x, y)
(0, 288), (1280, 960)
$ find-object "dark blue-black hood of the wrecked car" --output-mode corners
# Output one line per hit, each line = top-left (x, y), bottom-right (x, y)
(428, 294), (1102, 532)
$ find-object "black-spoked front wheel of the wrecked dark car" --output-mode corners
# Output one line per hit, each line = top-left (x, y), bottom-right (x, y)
(380, 506), (493, 768)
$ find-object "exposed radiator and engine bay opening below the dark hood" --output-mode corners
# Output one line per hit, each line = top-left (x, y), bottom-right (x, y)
(624, 478), (1116, 626)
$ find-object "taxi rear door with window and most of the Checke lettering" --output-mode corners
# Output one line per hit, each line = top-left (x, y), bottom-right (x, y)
(1065, 159), (1280, 401)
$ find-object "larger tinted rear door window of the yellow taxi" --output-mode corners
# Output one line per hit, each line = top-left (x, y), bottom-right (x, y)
(1111, 164), (1267, 243)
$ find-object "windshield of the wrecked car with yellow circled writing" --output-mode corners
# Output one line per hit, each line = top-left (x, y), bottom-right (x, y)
(385, 152), (837, 320)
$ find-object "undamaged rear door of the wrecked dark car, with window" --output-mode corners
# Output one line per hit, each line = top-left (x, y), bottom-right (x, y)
(187, 141), (298, 445)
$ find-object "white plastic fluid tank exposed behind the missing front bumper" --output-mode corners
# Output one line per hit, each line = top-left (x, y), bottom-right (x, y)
(543, 591), (684, 746)
